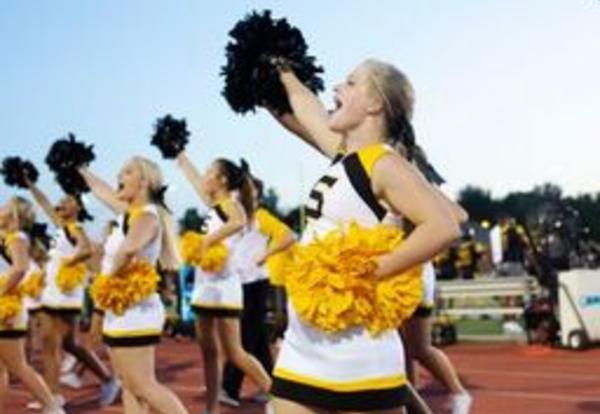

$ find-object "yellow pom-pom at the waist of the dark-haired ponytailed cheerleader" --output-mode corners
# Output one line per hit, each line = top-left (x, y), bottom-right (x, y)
(180, 231), (229, 273)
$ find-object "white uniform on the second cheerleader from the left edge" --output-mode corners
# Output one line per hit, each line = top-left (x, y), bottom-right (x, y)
(41, 223), (84, 314)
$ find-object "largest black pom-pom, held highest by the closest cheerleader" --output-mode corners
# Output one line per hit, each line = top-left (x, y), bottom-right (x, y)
(221, 10), (323, 114)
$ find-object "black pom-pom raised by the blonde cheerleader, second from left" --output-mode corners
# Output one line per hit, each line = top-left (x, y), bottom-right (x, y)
(46, 133), (96, 195)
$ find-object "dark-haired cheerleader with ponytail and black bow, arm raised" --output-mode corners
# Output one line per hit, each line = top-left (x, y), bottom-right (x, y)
(177, 152), (271, 414)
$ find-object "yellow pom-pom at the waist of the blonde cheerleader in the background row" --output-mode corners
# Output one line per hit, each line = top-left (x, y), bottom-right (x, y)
(90, 261), (160, 315)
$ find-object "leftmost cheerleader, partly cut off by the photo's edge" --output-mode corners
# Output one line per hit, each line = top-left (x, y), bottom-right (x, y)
(0, 197), (64, 414)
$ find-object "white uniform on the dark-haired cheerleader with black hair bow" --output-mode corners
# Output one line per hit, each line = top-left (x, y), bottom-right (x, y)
(191, 201), (244, 317)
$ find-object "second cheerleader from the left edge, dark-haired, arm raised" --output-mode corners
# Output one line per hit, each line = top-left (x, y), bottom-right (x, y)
(27, 182), (119, 408)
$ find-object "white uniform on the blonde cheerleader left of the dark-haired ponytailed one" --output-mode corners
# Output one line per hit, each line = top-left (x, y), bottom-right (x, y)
(102, 205), (165, 347)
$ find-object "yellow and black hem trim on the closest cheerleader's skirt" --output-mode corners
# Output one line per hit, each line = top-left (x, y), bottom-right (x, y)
(271, 368), (408, 411)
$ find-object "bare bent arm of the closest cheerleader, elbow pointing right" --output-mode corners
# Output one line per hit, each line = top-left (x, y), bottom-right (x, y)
(373, 154), (460, 277)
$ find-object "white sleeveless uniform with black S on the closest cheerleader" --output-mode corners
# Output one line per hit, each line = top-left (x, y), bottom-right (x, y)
(272, 145), (406, 411)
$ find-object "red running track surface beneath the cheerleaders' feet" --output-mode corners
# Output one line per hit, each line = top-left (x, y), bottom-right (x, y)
(2, 340), (600, 414)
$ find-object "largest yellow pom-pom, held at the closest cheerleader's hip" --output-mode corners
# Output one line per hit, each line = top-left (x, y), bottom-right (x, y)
(269, 223), (423, 336)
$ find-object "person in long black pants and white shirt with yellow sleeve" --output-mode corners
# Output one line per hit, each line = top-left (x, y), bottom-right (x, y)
(219, 178), (296, 407)
